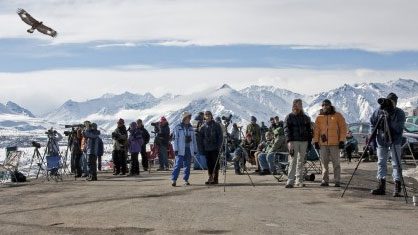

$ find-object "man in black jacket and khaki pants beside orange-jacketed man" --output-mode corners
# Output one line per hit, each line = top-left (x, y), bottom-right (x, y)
(283, 99), (312, 188)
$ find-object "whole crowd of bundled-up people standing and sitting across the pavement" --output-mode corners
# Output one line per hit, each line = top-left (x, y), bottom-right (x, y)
(49, 93), (405, 196)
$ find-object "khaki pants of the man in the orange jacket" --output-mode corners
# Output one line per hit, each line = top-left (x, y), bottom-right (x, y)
(319, 146), (341, 183)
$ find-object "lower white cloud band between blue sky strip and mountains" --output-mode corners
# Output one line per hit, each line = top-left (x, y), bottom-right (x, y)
(0, 66), (418, 114)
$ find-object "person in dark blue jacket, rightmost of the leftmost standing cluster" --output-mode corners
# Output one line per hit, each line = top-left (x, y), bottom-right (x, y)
(83, 123), (103, 181)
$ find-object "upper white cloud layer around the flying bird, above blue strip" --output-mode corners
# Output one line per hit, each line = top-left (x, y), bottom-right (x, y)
(0, 0), (418, 51)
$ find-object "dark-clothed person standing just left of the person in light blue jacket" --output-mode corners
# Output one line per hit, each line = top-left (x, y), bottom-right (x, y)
(154, 117), (170, 171)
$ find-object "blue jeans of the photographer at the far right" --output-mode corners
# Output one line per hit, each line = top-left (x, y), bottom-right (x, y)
(377, 145), (401, 181)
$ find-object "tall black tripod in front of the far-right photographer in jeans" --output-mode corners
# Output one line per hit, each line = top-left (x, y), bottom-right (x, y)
(341, 110), (408, 203)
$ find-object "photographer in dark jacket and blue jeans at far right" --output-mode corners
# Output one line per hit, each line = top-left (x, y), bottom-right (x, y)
(370, 93), (405, 197)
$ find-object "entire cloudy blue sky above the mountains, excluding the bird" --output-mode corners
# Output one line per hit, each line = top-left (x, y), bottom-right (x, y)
(0, 0), (418, 114)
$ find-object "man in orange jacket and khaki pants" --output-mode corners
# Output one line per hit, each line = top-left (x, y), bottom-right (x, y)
(313, 99), (347, 187)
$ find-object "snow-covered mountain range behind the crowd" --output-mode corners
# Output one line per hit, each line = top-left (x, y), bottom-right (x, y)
(0, 79), (418, 135)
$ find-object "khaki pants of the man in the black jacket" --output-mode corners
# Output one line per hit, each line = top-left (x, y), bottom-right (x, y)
(287, 141), (308, 185)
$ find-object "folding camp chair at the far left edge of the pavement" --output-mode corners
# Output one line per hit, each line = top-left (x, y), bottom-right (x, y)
(0, 147), (23, 183)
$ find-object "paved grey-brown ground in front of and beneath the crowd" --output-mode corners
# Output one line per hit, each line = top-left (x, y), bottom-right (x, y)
(0, 159), (418, 234)
